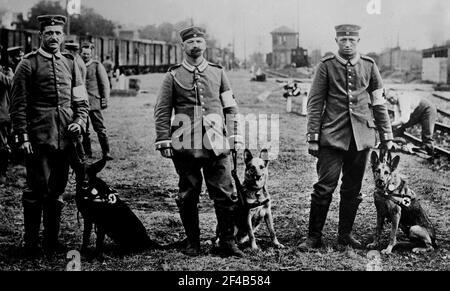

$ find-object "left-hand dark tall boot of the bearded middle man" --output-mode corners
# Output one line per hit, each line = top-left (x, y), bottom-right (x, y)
(177, 200), (200, 256)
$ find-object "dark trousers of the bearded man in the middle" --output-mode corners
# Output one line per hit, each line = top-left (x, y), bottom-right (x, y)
(173, 154), (234, 204)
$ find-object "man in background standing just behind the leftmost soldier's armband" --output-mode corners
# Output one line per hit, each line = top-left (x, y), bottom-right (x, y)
(81, 43), (113, 160)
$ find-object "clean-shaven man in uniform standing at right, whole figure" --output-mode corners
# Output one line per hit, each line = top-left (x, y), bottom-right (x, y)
(299, 25), (392, 251)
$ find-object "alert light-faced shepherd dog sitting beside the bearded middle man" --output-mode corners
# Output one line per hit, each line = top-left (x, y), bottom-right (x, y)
(223, 149), (284, 250)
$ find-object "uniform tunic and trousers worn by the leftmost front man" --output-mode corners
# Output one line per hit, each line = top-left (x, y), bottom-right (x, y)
(10, 48), (89, 203)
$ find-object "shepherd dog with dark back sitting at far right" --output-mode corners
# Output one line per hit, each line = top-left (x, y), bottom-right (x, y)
(367, 149), (436, 254)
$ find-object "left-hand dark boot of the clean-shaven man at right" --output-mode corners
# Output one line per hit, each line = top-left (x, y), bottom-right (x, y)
(298, 199), (331, 252)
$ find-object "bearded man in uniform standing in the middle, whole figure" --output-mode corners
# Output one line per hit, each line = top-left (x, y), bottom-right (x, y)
(154, 27), (243, 256)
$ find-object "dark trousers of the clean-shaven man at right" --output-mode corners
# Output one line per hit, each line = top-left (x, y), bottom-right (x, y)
(311, 138), (370, 205)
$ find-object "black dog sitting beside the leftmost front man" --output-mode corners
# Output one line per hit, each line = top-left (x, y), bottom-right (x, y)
(74, 159), (161, 258)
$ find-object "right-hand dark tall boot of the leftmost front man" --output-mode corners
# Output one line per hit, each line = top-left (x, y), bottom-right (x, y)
(43, 199), (67, 257)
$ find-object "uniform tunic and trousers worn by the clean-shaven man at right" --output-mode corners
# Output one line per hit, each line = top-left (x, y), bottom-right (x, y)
(307, 54), (392, 204)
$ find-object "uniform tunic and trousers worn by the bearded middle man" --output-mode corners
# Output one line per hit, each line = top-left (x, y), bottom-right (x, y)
(154, 60), (240, 205)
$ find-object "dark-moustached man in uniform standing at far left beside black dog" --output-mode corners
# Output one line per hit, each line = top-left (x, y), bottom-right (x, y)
(10, 15), (89, 256)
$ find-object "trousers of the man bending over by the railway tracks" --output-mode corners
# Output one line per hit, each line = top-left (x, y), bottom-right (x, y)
(400, 99), (437, 144)
